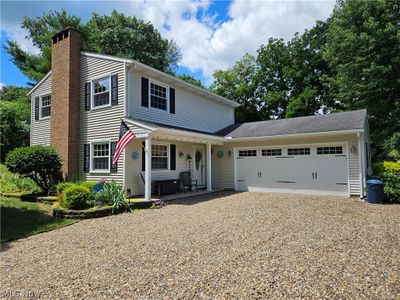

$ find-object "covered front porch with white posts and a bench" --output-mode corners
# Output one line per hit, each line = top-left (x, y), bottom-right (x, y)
(124, 120), (222, 201)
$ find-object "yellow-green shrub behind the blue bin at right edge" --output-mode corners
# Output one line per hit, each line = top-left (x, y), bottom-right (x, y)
(374, 161), (400, 202)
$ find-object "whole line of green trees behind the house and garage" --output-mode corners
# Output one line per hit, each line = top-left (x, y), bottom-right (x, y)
(0, 0), (400, 159)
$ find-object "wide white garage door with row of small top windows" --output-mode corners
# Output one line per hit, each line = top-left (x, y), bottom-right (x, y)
(235, 144), (349, 195)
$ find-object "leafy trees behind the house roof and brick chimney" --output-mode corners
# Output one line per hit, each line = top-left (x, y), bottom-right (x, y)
(5, 10), (180, 83)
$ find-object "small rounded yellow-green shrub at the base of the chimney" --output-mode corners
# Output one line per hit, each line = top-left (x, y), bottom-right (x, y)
(60, 184), (92, 209)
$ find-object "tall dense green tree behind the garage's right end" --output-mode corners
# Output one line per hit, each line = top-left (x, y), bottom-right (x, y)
(324, 0), (400, 158)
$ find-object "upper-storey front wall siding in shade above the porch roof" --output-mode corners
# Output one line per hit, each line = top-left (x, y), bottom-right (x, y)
(128, 71), (234, 132)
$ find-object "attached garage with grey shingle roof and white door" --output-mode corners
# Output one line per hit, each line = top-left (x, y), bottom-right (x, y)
(212, 110), (372, 197)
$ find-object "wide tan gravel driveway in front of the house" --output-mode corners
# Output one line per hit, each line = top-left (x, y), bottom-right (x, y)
(0, 193), (400, 299)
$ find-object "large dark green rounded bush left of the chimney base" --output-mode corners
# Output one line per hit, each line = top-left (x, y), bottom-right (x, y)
(6, 145), (62, 194)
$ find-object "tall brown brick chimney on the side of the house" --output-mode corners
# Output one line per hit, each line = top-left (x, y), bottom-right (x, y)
(51, 28), (81, 179)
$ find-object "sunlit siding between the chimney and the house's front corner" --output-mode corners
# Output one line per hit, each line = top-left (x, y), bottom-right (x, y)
(79, 55), (125, 184)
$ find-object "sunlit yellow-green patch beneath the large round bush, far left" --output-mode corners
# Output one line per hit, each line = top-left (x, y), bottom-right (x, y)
(0, 164), (40, 193)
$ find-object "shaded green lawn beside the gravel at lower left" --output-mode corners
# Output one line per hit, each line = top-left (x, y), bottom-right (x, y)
(0, 197), (77, 242)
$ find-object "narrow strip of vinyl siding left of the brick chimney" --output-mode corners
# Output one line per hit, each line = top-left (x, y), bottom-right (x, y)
(30, 74), (51, 146)
